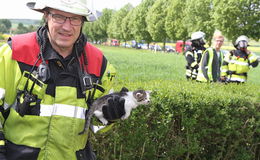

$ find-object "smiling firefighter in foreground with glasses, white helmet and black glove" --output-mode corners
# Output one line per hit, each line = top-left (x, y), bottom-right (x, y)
(0, 0), (125, 160)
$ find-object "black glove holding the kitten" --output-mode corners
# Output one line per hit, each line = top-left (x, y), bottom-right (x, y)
(102, 95), (125, 122)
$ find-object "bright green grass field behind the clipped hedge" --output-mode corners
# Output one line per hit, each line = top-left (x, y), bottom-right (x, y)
(97, 46), (260, 85)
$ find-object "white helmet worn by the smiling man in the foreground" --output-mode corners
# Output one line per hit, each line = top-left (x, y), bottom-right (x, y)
(27, 0), (97, 21)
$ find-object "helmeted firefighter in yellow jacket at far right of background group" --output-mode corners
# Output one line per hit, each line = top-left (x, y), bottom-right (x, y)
(221, 35), (258, 83)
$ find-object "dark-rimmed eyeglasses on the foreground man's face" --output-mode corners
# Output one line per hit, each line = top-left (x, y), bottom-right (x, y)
(49, 12), (83, 26)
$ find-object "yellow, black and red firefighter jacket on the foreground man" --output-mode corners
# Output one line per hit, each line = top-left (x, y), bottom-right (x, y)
(0, 28), (115, 160)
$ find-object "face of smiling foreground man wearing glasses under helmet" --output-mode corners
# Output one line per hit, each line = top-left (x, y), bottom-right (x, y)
(45, 9), (83, 49)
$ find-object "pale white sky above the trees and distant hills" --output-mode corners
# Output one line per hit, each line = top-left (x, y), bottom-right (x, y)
(0, 0), (142, 20)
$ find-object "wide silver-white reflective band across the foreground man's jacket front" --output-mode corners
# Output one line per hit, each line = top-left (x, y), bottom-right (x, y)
(40, 104), (86, 119)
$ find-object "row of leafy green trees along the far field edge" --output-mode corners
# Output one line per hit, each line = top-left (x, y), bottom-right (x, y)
(83, 0), (260, 47)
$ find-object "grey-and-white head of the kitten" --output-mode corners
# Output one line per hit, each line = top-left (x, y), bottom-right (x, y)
(133, 89), (151, 105)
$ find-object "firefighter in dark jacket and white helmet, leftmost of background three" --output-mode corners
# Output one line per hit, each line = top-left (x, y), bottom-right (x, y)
(184, 31), (206, 80)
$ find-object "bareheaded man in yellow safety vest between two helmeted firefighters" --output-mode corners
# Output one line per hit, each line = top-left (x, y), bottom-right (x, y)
(197, 34), (224, 82)
